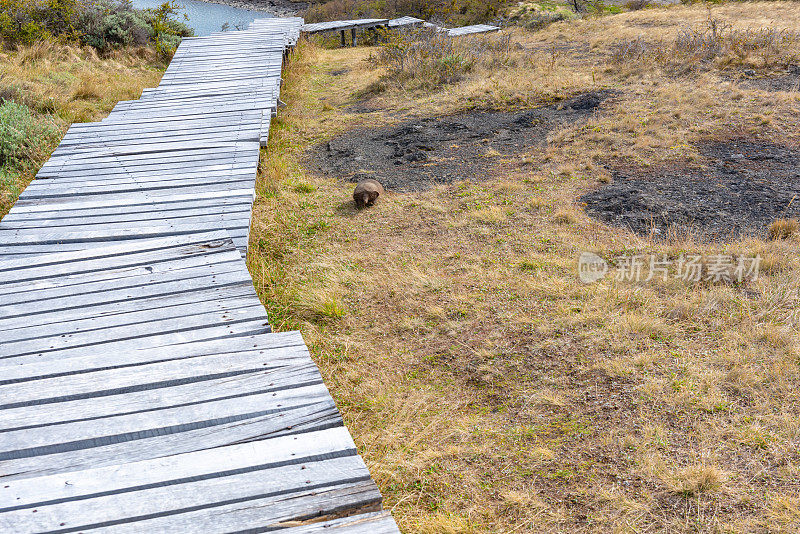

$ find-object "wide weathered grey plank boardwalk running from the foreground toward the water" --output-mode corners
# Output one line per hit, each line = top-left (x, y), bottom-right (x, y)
(0, 19), (398, 534)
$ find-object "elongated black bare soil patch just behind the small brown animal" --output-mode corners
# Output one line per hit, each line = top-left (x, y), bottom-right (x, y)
(310, 92), (609, 191)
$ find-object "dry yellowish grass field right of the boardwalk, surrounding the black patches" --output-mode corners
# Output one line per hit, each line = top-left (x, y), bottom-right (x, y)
(249, 3), (800, 532)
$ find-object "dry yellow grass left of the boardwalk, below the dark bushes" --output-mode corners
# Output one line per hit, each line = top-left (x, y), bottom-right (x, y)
(0, 42), (164, 217)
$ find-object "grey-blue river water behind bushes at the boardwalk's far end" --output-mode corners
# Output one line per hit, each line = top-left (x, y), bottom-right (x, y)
(132, 0), (272, 36)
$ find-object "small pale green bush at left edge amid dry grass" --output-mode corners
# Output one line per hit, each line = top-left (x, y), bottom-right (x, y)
(0, 100), (60, 173)
